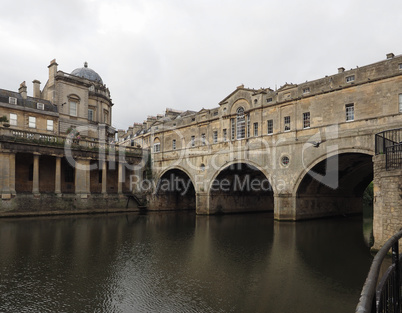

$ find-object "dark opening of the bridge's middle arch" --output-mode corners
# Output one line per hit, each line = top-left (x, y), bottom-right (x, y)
(209, 163), (274, 213)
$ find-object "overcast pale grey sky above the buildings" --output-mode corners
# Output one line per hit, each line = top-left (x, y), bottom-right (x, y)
(0, 0), (402, 129)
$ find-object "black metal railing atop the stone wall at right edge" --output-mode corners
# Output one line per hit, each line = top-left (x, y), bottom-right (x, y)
(375, 128), (402, 170)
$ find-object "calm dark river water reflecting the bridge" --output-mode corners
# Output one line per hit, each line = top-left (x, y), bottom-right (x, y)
(0, 213), (372, 313)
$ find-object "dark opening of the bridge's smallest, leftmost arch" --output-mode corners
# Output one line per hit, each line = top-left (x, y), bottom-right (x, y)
(155, 169), (196, 210)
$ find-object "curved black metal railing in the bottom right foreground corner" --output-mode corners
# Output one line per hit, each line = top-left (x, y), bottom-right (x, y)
(356, 229), (402, 313)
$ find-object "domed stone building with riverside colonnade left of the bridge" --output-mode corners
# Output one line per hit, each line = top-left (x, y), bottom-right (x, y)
(0, 60), (142, 216)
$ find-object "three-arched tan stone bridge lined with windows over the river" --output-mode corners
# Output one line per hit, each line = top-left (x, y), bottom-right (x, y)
(144, 55), (402, 249)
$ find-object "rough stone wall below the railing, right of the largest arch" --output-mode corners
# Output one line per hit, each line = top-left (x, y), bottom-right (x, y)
(372, 154), (402, 250)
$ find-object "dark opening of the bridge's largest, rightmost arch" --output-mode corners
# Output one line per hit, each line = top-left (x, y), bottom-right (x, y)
(293, 149), (373, 219)
